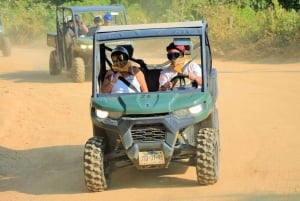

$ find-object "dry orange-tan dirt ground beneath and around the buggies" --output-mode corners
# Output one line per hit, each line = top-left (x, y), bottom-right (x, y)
(0, 46), (300, 201)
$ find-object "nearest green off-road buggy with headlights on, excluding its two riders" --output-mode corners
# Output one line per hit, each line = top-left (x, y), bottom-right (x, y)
(83, 21), (219, 191)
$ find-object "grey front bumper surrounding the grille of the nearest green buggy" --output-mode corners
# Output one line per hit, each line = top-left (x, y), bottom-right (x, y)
(92, 114), (196, 169)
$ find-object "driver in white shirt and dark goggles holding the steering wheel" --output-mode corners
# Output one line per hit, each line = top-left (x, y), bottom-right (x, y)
(159, 43), (202, 91)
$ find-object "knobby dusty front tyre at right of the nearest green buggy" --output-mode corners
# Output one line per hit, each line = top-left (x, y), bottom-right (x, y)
(196, 128), (219, 185)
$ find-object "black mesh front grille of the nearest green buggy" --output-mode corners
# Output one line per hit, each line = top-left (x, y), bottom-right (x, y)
(131, 124), (167, 142)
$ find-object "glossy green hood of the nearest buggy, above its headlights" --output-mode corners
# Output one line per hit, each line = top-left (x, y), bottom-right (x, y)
(92, 90), (212, 114)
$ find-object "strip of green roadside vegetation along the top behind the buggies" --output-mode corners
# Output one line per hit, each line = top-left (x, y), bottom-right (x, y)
(0, 0), (300, 57)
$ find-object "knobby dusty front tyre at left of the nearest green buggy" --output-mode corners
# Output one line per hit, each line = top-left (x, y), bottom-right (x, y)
(84, 136), (109, 192)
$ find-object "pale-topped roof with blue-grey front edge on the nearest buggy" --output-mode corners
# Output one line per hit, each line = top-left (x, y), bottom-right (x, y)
(95, 21), (207, 41)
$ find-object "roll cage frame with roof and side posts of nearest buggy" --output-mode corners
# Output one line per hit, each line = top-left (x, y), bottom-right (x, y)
(92, 21), (212, 97)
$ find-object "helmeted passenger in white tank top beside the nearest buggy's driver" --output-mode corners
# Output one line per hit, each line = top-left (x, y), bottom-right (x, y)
(101, 46), (148, 93)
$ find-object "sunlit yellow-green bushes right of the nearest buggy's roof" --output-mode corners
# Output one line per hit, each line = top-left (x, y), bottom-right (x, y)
(196, 0), (300, 56)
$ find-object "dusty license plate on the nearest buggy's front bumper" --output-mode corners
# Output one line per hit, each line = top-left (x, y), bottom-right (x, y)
(139, 151), (165, 165)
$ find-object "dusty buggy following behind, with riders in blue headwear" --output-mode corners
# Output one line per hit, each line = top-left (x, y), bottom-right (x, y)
(47, 5), (127, 82)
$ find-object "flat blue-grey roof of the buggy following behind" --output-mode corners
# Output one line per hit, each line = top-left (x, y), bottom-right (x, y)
(58, 5), (125, 13)
